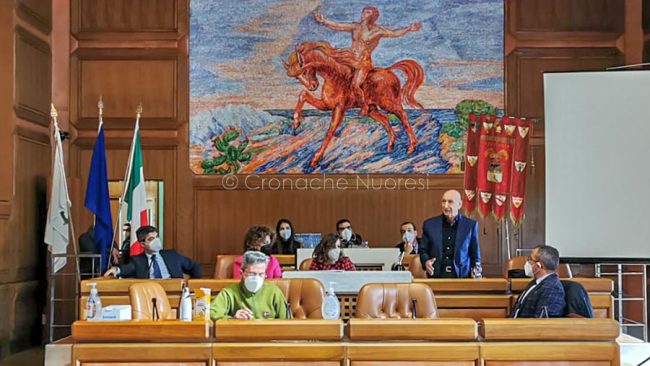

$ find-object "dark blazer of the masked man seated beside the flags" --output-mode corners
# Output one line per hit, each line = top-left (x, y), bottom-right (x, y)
(120, 250), (202, 278)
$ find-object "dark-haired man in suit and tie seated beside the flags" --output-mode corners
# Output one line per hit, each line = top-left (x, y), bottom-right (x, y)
(104, 226), (201, 278)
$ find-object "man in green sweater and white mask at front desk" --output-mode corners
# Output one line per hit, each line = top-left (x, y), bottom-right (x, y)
(210, 251), (287, 321)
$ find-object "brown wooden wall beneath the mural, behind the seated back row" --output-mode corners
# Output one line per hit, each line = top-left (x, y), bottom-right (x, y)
(193, 187), (500, 273)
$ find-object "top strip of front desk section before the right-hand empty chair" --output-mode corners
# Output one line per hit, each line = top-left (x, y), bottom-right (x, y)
(348, 319), (478, 341)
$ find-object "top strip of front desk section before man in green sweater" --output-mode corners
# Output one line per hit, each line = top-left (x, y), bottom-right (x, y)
(214, 319), (343, 342)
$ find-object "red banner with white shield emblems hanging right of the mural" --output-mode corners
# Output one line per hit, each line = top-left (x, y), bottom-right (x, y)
(463, 114), (530, 224)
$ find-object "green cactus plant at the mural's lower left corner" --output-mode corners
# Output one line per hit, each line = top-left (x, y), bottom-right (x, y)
(201, 128), (253, 174)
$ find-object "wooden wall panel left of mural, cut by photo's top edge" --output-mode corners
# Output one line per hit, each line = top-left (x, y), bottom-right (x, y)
(73, 0), (178, 32)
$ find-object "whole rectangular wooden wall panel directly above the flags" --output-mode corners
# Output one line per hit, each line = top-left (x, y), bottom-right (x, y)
(79, 60), (176, 120)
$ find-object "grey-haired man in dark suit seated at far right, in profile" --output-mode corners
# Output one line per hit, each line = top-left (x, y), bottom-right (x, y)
(510, 245), (566, 318)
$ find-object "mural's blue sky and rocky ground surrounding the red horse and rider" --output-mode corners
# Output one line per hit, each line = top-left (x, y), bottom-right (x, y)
(189, 0), (504, 174)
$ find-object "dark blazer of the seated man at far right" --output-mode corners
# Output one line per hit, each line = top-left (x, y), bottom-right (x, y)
(510, 273), (566, 318)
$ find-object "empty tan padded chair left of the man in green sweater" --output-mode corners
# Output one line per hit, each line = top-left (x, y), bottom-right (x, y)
(129, 281), (174, 320)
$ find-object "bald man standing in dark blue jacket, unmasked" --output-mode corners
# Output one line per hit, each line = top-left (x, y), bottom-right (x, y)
(420, 190), (481, 278)
